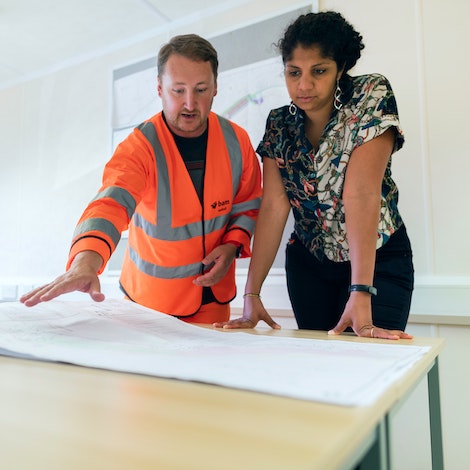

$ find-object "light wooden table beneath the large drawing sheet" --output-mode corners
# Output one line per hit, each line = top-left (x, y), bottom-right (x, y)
(0, 329), (443, 470)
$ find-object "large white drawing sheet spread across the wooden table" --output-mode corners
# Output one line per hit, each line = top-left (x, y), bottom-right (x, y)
(0, 300), (429, 406)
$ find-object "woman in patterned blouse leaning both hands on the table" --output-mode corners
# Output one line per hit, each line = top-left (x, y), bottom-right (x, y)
(215, 12), (414, 339)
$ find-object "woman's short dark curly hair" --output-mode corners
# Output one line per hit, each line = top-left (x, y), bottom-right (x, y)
(277, 11), (364, 75)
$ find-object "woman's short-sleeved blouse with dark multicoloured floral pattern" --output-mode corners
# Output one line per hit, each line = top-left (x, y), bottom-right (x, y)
(257, 74), (404, 262)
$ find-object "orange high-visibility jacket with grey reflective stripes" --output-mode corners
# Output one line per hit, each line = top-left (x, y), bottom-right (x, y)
(68, 113), (261, 316)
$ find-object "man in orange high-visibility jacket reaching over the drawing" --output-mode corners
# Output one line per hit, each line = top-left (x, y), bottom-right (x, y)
(20, 34), (261, 323)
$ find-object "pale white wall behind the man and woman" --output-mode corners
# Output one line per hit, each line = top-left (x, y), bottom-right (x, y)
(0, 0), (470, 470)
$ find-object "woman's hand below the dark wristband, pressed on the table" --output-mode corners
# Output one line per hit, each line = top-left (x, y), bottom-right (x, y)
(328, 292), (413, 340)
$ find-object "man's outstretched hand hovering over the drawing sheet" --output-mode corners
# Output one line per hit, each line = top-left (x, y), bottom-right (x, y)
(20, 251), (104, 307)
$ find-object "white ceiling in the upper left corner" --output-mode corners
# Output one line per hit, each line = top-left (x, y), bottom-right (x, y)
(0, 0), (237, 89)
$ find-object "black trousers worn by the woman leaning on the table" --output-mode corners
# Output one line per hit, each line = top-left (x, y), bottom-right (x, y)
(286, 226), (414, 331)
